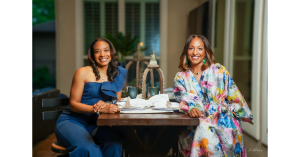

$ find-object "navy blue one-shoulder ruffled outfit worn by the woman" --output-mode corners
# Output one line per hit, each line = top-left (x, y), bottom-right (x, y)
(55, 66), (127, 157)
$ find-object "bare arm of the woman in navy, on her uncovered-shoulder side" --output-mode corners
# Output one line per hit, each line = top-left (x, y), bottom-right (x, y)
(70, 68), (94, 114)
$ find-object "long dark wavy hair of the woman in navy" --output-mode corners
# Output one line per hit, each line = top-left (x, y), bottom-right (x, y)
(87, 38), (119, 82)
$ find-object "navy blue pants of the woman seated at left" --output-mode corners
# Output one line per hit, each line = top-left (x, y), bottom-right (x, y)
(55, 120), (123, 157)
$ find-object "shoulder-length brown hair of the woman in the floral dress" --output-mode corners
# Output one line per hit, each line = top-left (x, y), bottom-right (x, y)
(178, 34), (216, 72)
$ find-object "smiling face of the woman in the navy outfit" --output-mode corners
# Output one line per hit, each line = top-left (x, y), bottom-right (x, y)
(94, 41), (111, 67)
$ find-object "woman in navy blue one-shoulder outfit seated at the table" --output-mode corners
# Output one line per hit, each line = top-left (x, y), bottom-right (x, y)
(55, 38), (127, 157)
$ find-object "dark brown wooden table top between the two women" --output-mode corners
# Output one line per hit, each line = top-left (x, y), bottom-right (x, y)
(97, 112), (199, 126)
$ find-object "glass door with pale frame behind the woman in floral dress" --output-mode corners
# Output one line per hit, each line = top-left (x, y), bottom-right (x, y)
(216, 0), (264, 140)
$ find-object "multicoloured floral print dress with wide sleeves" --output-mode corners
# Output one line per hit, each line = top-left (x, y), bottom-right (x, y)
(173, 63), (253, 157)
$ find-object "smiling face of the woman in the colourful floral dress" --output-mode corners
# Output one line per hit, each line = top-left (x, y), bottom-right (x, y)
(187, 37), (206, 66)
